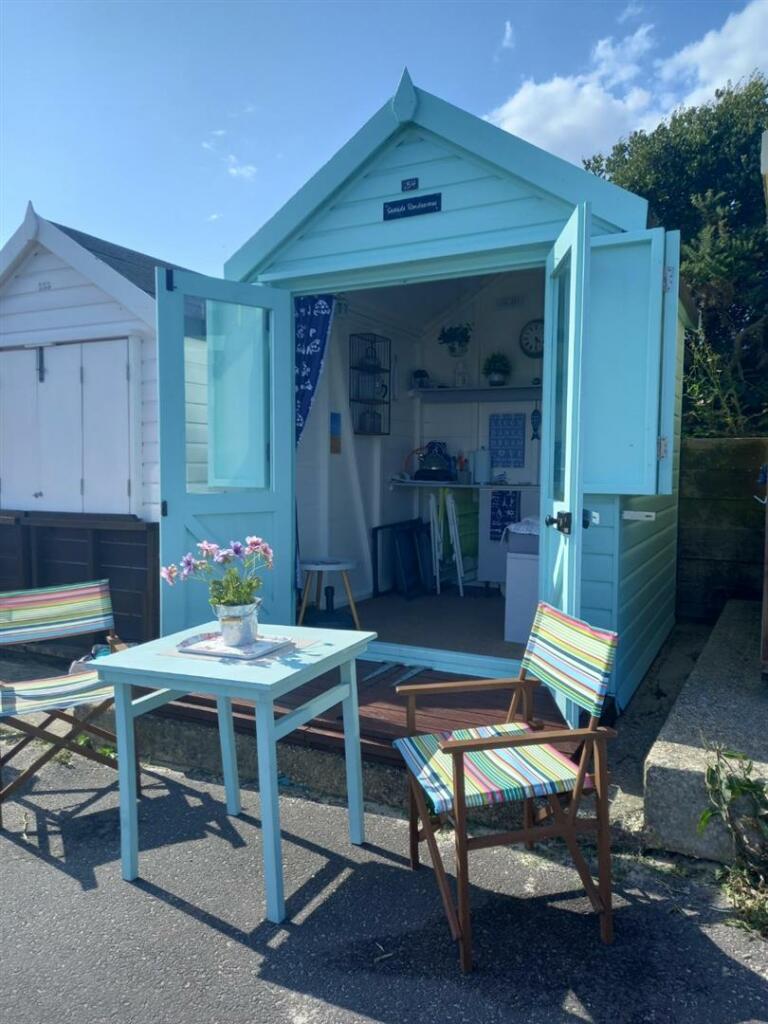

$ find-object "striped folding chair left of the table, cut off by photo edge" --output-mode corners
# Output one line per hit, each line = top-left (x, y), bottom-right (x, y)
(0, 580), (131, 827)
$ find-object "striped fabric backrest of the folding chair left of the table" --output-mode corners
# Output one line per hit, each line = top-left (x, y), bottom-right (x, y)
(0, 580), (115, 646)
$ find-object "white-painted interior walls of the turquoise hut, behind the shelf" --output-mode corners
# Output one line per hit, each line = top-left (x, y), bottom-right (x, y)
(296, 270), (544, 604)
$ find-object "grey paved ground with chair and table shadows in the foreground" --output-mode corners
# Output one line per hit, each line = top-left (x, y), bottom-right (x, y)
(0, 759), (768, 1024)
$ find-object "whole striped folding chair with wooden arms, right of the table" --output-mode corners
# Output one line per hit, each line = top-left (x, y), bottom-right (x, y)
(394, 602), (618, 971)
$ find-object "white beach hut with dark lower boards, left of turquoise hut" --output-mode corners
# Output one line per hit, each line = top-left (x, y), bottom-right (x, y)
(0, 204), (185, 640)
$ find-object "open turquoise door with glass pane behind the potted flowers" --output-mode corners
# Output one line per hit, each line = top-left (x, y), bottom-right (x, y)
(157, 269), (295, 634)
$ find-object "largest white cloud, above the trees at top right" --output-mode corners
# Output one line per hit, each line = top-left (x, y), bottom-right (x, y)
(486, 0), (768, 163)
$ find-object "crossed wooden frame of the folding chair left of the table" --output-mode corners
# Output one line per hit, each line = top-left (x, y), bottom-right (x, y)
(0, 593), (141, 828)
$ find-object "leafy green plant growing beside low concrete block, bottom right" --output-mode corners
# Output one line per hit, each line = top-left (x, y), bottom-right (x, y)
(698, 746), (768, 936)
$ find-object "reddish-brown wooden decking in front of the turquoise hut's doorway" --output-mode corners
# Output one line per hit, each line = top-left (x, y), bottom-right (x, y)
(159, 662), (563, 765)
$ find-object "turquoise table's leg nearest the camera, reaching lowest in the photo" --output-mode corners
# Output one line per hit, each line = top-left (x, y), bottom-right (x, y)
(256, 700), (286, 925)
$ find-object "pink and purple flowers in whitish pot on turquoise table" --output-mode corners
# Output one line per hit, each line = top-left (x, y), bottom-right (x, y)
(160, 537), (272, 647)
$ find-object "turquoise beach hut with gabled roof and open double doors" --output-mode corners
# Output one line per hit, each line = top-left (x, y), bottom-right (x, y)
(157, 72), (685, 717)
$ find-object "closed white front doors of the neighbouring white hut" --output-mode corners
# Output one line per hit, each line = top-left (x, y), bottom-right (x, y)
(0, 339), (140, 513)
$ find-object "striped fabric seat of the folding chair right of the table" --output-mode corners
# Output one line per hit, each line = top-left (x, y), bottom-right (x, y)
(394, 722), (589, 814)
